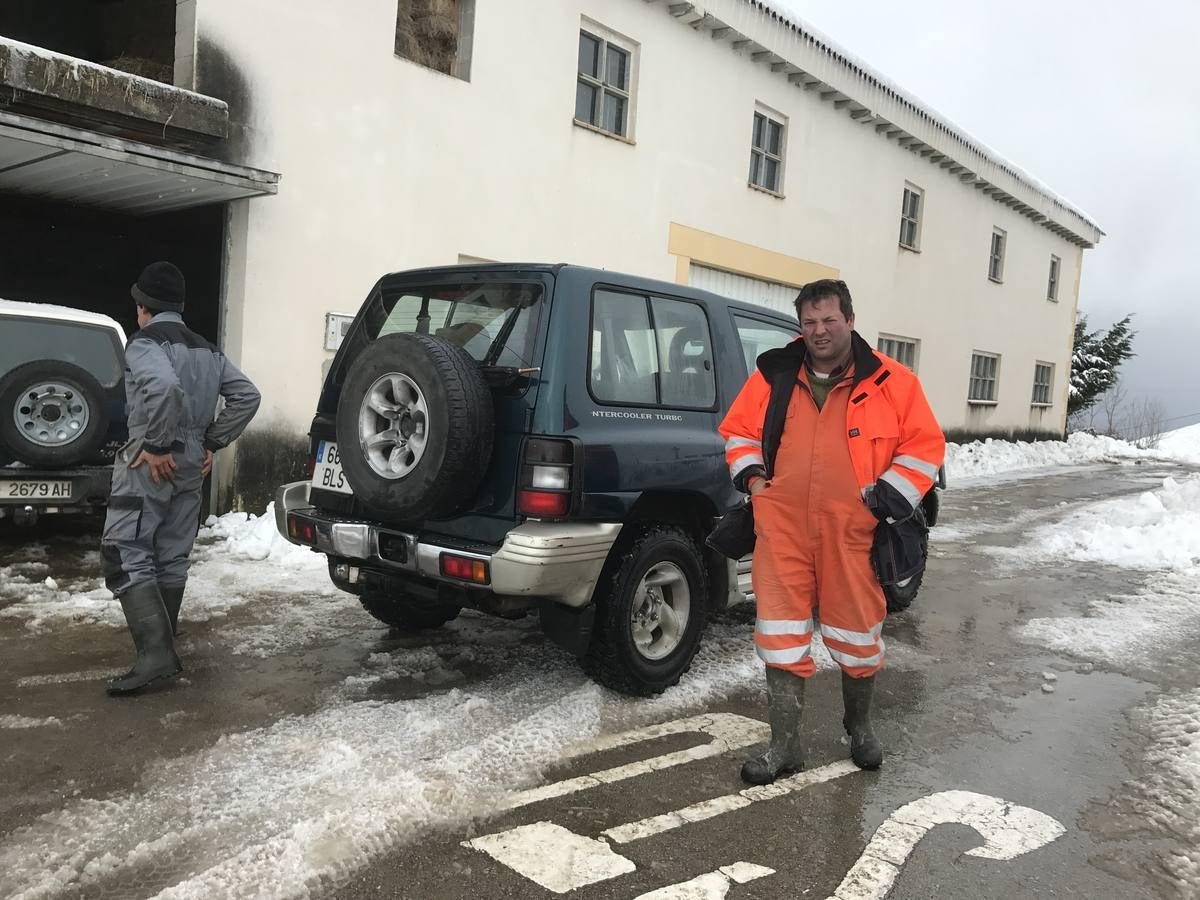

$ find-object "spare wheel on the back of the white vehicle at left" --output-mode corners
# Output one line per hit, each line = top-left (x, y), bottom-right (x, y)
(0, 360), (109, 468)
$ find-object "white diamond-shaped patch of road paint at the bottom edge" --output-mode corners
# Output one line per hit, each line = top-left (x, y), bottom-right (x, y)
(463, 822), (637, 894)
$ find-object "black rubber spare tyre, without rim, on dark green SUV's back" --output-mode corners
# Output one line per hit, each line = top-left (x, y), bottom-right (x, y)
(337, 334), (493, 521)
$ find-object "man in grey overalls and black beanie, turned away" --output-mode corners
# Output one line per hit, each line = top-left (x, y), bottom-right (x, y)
(101, 263), (259, 694)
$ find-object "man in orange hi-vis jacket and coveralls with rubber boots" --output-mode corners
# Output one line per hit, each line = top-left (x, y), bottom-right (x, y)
(720, 280), (946, 785)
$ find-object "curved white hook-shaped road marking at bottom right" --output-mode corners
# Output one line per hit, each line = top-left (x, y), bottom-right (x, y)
(829, 791), (1067, 900)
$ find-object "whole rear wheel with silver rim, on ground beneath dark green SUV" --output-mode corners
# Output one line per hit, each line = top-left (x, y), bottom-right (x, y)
(583, 526), (708, 697)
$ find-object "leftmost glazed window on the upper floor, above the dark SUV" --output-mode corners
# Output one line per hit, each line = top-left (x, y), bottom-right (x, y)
(575, 22), (635, 138)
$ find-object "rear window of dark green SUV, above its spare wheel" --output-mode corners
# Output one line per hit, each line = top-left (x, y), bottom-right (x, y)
(364, 282), (542, 368)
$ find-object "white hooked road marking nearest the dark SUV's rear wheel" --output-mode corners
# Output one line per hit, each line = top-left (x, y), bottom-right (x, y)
(500, 713), (770, 811)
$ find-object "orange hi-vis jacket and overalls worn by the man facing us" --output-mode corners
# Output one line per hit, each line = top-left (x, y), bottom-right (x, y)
(720, 334), (946, 677)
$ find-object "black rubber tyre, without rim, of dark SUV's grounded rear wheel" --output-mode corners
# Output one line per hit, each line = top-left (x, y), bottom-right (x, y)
(583, 526), (708, 697)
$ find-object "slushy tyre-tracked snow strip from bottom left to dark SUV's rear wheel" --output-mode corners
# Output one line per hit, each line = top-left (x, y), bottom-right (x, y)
(0, 623), (816, 898)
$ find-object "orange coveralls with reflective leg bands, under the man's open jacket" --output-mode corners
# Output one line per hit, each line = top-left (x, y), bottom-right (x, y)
(751, 368), (887, 678)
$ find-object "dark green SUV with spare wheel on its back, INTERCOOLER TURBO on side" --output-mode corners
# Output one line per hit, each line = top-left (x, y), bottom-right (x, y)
(275, 265), (931, 695)
